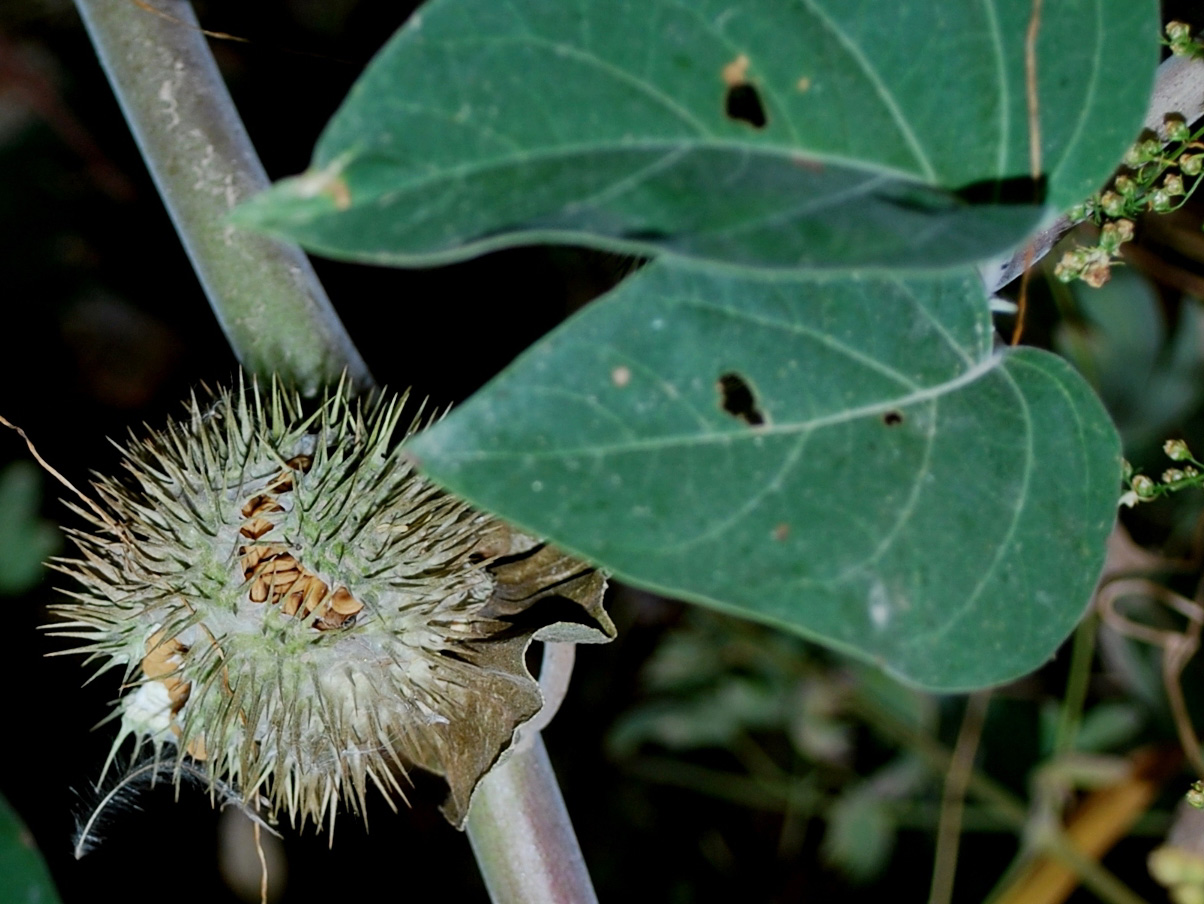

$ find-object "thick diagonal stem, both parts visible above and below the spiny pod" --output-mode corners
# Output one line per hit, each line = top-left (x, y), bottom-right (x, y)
(76, 0), (596, 904)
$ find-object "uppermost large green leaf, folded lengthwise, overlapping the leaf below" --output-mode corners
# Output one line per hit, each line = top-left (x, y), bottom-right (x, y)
(237, 0), (1158, 268)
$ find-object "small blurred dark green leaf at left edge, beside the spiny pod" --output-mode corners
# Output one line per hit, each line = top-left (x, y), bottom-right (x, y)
(0, 461), (59, 595)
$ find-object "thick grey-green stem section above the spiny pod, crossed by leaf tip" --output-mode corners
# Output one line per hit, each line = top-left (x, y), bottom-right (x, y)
(76, 0), (372, 395)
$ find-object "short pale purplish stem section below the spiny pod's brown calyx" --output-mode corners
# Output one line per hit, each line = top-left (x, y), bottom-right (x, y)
(467, 734), (597, 904)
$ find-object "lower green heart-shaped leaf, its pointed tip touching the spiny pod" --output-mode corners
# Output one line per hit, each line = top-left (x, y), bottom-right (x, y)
(411, 262), (1120, 690)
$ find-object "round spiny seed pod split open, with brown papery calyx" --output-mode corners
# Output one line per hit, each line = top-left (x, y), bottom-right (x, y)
(55, 385), (614, 826)
